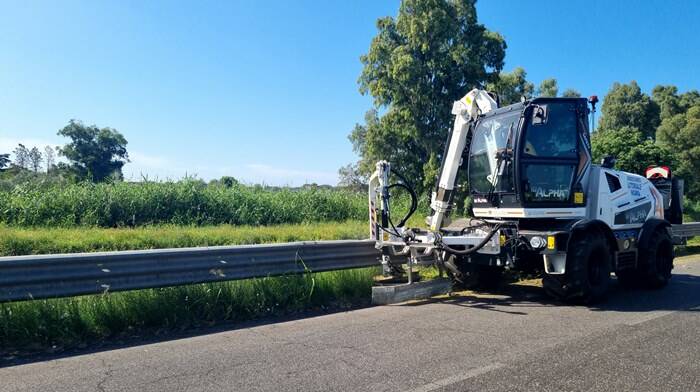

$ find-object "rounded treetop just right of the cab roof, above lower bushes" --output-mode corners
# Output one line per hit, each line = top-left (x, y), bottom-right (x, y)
(598, 81), (660, 139)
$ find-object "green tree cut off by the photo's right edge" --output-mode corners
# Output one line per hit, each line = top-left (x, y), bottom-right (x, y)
(657, 102), (700, 200)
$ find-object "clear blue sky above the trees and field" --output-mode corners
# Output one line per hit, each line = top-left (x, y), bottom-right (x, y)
(0, 0), (700, 185)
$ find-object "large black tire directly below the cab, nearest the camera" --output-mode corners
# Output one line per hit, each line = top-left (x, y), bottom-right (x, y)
(542, 231), (612, 304)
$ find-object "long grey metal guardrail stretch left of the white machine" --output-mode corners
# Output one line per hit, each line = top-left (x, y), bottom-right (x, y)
(0, 240), (379, 302)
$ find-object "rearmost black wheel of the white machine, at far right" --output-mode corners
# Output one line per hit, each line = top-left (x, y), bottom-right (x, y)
(639, 229), (674, 289)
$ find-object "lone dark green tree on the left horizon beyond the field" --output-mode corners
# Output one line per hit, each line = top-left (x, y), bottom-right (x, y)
(58, 120), (129, 182)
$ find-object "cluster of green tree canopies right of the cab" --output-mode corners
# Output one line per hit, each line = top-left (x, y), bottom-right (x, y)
(591, 81), (700, 200)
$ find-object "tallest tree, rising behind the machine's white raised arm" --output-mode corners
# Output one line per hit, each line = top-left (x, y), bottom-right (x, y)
(349, 0), (506, 191)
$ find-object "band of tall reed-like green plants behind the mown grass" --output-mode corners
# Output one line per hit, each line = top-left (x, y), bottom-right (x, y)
(0, 180), (378, 227)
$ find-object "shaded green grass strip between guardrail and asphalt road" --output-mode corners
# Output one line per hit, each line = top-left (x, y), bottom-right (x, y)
(0, 268), (379, 358)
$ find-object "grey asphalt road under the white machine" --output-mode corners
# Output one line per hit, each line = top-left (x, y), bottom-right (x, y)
(0, 256), (700, 392)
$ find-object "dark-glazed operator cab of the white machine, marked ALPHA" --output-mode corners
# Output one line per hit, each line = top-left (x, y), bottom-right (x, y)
(468, 98), (591, 217)
